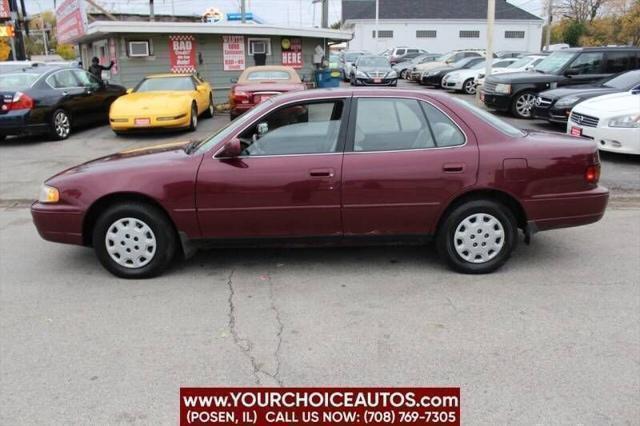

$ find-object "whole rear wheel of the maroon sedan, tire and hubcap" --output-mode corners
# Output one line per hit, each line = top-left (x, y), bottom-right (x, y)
(437, 200), (518, 274)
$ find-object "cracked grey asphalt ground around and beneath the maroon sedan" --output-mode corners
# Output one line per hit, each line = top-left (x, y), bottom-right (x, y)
(0, 85), (640, 424)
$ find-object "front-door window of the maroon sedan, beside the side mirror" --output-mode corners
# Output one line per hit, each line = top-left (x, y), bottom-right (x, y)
(239, 100), (344, 157)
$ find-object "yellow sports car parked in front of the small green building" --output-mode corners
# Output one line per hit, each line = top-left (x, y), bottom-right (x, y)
(109, 74), (214, 134)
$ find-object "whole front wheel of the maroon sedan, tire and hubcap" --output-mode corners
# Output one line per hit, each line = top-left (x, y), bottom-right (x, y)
(93, 203), (177, 278)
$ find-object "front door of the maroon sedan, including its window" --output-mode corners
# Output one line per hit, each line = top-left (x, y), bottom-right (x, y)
(196, 98), (349, 238)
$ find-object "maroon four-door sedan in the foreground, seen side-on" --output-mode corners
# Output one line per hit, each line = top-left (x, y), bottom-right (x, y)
(32, 89), (608, 278)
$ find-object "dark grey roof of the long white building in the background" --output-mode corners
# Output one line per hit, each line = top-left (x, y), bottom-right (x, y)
(342, 0), (540, 22)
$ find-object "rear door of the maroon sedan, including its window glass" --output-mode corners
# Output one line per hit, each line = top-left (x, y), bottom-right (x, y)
(342, 97), (478, 236)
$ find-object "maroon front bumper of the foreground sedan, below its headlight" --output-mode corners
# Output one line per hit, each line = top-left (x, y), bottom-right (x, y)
(31, 202), (84, 245)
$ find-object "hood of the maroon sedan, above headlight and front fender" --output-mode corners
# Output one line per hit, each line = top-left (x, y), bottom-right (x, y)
(48, 140), (192, 181)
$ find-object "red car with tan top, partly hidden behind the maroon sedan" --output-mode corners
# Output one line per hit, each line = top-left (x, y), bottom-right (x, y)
(229, 65), (306, 120)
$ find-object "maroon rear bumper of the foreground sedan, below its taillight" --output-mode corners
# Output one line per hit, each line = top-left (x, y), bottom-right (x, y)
(523, 186), (609, 231)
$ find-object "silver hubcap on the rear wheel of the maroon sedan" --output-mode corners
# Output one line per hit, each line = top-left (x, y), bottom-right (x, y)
(453, 213), (504, 263)
